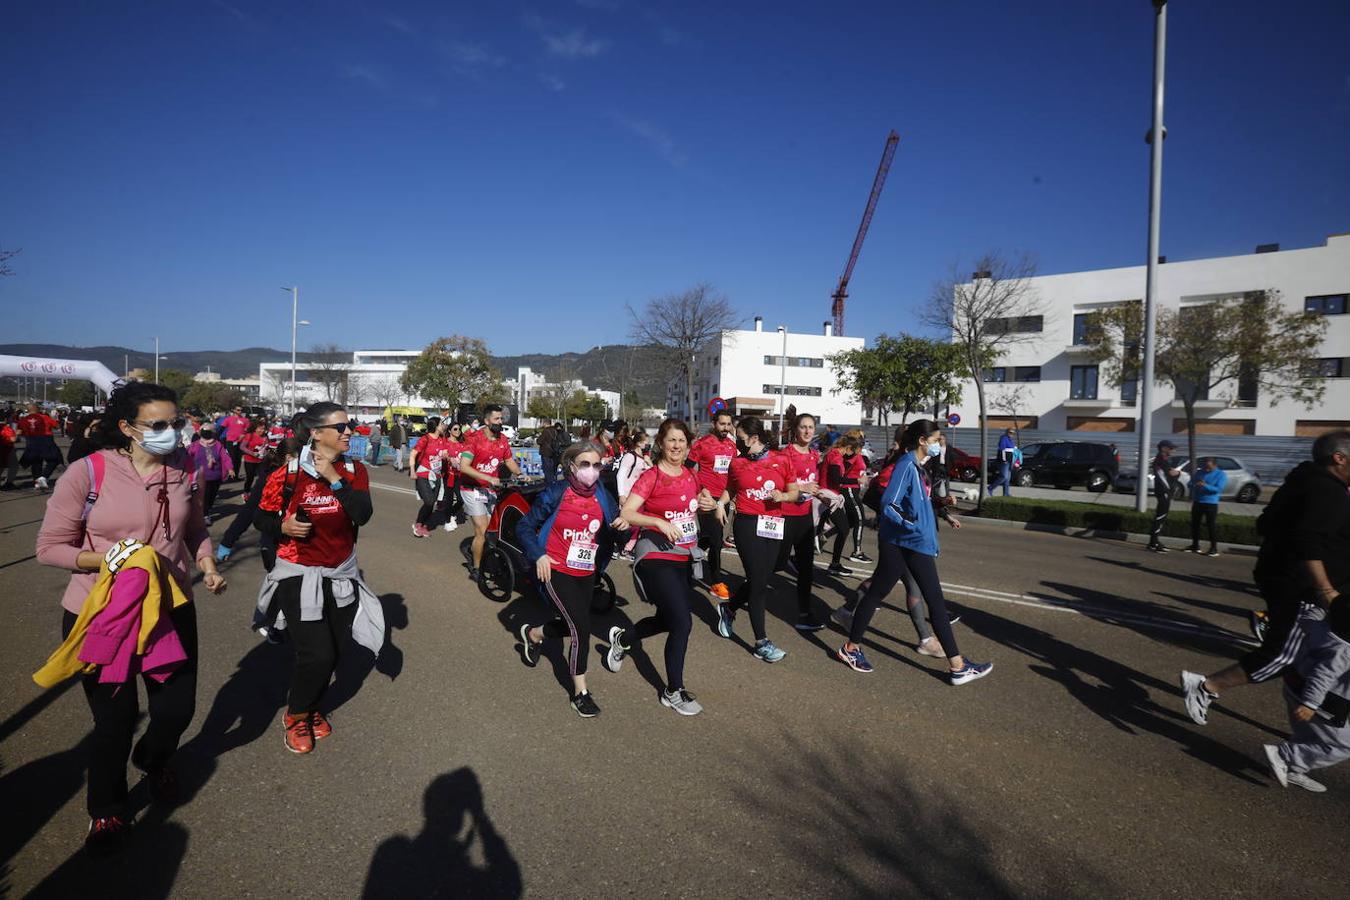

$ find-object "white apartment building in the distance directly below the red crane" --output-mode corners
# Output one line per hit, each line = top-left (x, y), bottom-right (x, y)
(666, 316), (864, 426)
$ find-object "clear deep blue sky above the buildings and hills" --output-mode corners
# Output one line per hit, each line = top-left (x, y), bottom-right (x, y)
(0, 0), (1350, 354)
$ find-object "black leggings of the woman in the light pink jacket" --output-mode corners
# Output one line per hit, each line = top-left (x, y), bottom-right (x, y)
(61, 603), (197, 819)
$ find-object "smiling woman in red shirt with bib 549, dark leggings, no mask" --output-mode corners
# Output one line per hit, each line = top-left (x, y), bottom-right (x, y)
(606, 418), (717, 715)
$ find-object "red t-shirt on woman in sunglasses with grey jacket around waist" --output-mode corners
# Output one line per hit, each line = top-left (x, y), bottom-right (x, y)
(258, 460), (370, 568)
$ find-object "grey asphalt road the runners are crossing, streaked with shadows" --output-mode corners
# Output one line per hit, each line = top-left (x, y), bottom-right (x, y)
(0, 468), (1350, 897)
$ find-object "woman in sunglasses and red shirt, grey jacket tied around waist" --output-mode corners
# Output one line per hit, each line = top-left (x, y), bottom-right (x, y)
(254, 403), (385, 753)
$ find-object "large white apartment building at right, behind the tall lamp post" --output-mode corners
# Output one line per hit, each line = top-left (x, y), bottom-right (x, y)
(952, 235), (1350, 436)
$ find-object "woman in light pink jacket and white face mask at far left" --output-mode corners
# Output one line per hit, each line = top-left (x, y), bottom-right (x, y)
(36, 382), (225, 854)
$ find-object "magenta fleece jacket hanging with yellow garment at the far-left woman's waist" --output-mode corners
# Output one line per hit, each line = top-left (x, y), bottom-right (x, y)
(80, 568), (188, 684)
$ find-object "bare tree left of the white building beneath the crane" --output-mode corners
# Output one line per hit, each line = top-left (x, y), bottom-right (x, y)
(628, 282), (740, 418)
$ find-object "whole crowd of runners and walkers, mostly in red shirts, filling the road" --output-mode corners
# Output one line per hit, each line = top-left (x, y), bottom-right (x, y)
(18, 383), (1350, 853)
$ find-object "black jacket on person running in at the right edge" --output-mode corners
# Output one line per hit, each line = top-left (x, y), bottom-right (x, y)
(1254, 461), (1350, 591)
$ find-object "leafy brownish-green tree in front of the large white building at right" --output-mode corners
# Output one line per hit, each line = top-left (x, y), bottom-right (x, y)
(1087, 290), (1327, 469)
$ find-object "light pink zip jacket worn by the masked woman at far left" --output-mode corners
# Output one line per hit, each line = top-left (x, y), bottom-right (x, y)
(38, 451), (212, 615)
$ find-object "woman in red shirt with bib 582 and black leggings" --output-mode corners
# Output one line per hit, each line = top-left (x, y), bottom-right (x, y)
(717, 417), (801, 663)
